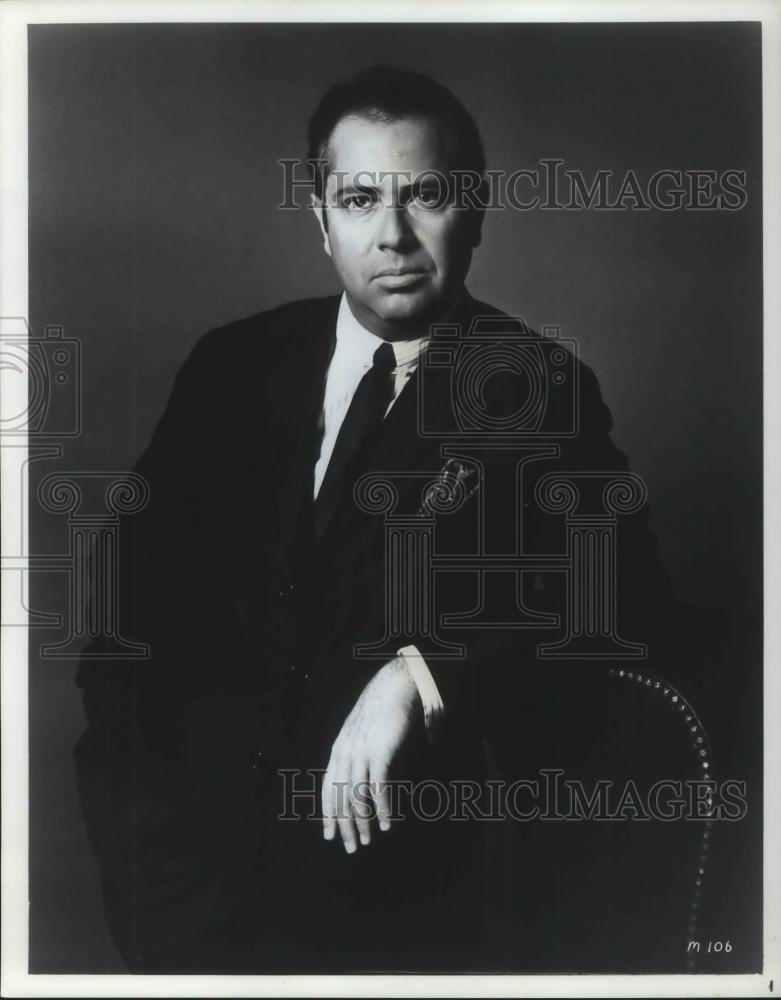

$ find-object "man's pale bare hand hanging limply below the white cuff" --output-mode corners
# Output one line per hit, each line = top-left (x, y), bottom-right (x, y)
(323, 656), (423, 854)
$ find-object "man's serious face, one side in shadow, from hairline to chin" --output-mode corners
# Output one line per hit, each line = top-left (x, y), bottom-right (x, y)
(313, 116), (480, 340)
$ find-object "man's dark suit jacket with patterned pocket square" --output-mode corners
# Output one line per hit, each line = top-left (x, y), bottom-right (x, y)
(77, 295), (696, 971)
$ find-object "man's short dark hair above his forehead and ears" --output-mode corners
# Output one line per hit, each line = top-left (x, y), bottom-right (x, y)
(307, 66), (485, 197)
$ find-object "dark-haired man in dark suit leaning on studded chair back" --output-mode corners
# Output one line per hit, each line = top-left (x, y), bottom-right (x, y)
(77, 67), (688, 972)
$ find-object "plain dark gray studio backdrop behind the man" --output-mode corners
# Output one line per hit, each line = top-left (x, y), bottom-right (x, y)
(29, 24), (762, 971)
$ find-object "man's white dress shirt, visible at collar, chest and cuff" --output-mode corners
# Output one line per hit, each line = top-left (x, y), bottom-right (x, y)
(314, 294), (445, 737)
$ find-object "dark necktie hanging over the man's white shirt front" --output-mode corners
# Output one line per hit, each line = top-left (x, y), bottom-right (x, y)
(315, 343), (396, 539)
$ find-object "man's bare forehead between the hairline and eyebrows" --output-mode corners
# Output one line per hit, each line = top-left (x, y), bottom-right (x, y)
(328, 115), (445, 183)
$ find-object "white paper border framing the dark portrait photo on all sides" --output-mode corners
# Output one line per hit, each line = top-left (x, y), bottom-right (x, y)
(0, 0), (781, 997)
